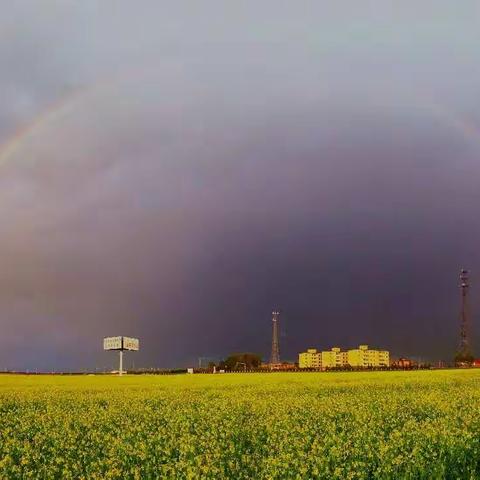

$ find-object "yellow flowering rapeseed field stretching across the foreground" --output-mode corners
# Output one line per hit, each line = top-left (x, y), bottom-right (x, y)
(0, 370), (480, 480)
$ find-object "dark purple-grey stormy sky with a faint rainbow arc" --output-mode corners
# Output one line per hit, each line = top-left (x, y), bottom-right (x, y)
(0, 0), (480, 371)
